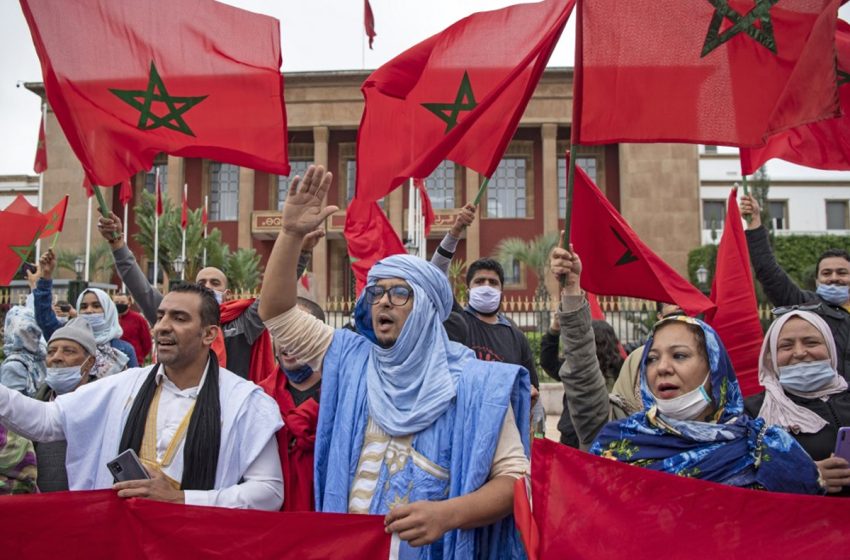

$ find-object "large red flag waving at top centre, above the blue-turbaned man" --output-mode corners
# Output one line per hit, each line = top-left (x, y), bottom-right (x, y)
(356, 0), (575, 201)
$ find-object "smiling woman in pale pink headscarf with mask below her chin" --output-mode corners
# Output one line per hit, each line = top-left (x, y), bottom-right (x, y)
(746, 310), (850, 495)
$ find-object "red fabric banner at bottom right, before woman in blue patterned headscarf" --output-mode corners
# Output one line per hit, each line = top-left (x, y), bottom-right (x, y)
(517, 439), (850, 560)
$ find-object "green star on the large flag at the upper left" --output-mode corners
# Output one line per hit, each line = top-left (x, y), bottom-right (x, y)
(109, 61), (208, 136)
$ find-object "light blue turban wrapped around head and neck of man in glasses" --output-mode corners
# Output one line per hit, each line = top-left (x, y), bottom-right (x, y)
(354, 255), (474, 436)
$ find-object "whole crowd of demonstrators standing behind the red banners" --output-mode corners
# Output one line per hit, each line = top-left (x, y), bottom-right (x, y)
(0, 166), (850, 558)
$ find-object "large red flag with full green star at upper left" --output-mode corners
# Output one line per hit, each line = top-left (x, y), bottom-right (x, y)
(21, 0), (289, 185)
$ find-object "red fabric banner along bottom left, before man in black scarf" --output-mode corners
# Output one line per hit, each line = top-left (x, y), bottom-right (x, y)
(0, 490), (390, 560)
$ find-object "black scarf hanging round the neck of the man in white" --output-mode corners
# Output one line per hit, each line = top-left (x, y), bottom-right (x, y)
(118, 351), (221, 490)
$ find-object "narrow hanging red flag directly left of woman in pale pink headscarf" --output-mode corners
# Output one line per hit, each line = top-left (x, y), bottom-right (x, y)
(705, 189), (764, 397)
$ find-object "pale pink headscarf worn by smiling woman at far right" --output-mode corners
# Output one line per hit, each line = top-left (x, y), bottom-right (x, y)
(759, 310), (847, 434)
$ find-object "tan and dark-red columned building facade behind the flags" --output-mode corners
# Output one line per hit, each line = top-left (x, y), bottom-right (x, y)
(28, 68), (701, 303)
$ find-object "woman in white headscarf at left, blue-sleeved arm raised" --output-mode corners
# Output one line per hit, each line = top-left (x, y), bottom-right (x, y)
(32, 251), (139, 378)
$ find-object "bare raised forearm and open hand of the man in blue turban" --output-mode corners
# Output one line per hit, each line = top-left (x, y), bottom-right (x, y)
(259, 165), (339, 321)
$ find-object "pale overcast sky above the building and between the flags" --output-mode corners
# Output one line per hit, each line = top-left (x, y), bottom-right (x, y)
(0, 0), (575, 175)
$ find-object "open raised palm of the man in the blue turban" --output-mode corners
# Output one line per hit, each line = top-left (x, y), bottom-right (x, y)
(281, 165), (339, 237)
